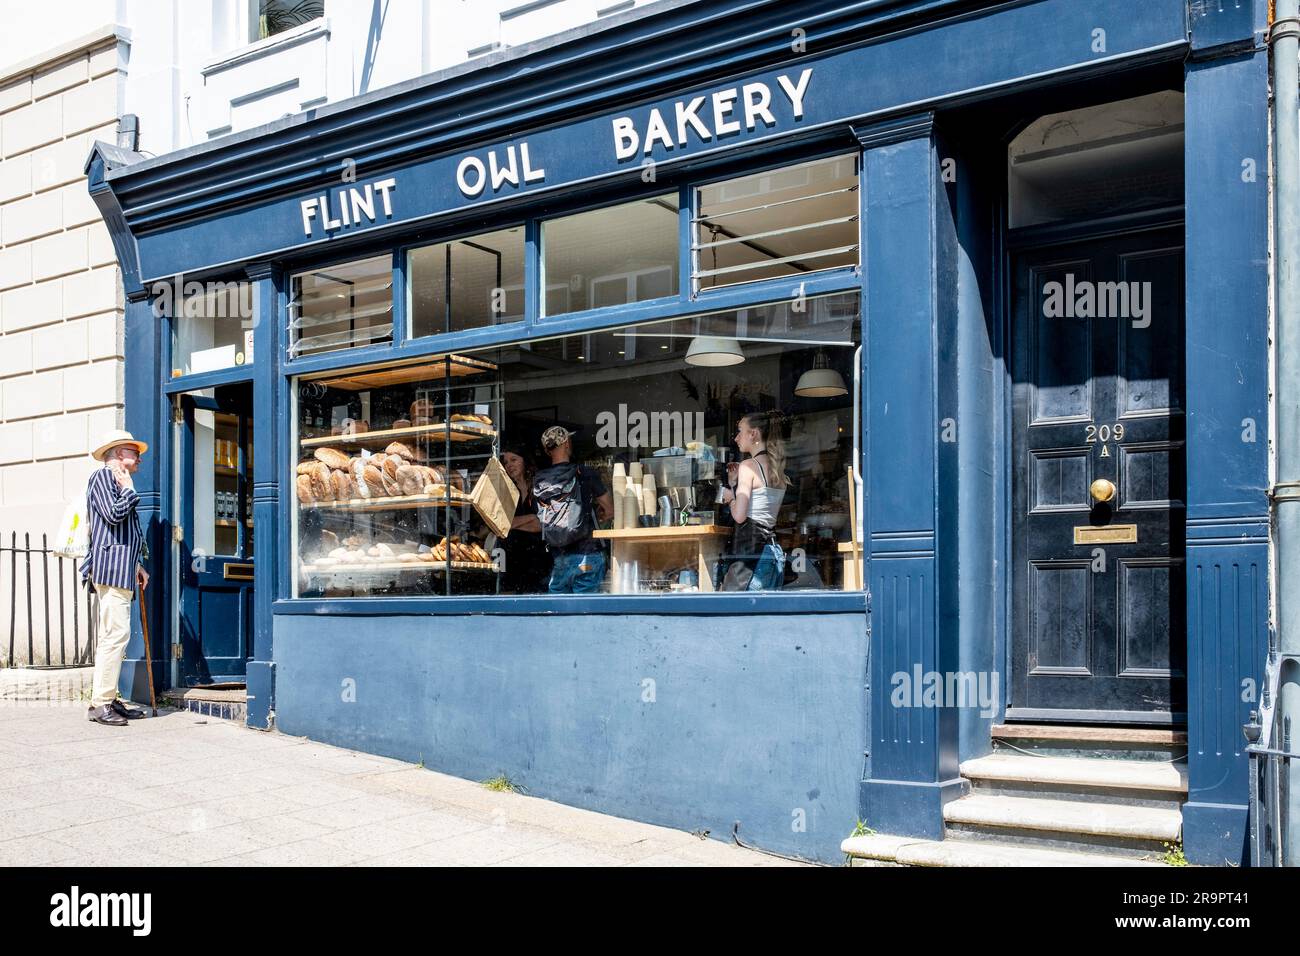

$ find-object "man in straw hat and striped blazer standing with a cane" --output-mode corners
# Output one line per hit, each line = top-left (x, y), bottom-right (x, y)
(82, 429), (150, 727)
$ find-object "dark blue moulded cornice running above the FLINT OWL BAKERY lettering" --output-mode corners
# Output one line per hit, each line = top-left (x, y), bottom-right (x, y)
(96, 0), (1055, 220)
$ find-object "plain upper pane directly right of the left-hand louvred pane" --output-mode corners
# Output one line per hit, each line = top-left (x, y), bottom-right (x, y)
(410, 226), (524, 336)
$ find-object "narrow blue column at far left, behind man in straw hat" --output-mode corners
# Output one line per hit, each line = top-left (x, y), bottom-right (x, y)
(117, 289), (170, 704)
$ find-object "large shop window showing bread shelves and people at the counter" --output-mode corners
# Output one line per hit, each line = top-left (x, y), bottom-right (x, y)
(293, 293), (861, 597)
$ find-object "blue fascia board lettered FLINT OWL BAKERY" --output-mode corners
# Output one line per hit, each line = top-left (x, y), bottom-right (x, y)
(116, 6), (1187, 287)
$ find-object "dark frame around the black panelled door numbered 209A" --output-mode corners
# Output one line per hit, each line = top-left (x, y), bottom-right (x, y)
(997, 204), (1191, 727)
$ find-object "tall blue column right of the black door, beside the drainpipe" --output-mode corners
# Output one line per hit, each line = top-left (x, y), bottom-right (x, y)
(1183, 49), (1269, 864)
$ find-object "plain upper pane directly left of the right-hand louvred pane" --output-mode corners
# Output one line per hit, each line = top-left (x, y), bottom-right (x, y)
(542, 194), (677, 315)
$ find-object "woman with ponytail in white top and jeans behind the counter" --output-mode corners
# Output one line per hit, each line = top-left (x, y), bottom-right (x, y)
(715, 411), (789, 591)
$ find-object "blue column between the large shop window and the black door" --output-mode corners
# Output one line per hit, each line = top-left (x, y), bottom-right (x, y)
(857, 113), (961, 839)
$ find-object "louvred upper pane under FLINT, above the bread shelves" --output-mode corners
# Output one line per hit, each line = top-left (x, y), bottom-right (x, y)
(289, 255), (393, 358)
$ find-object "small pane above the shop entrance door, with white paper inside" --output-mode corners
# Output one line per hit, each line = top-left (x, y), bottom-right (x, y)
(172, 282), (252, 378)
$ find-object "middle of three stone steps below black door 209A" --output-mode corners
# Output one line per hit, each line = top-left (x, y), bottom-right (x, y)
(944, 793), (1183, 843)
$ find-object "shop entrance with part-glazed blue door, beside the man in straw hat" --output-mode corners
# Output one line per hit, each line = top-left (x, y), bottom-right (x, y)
(177, 382), (254, 689)
